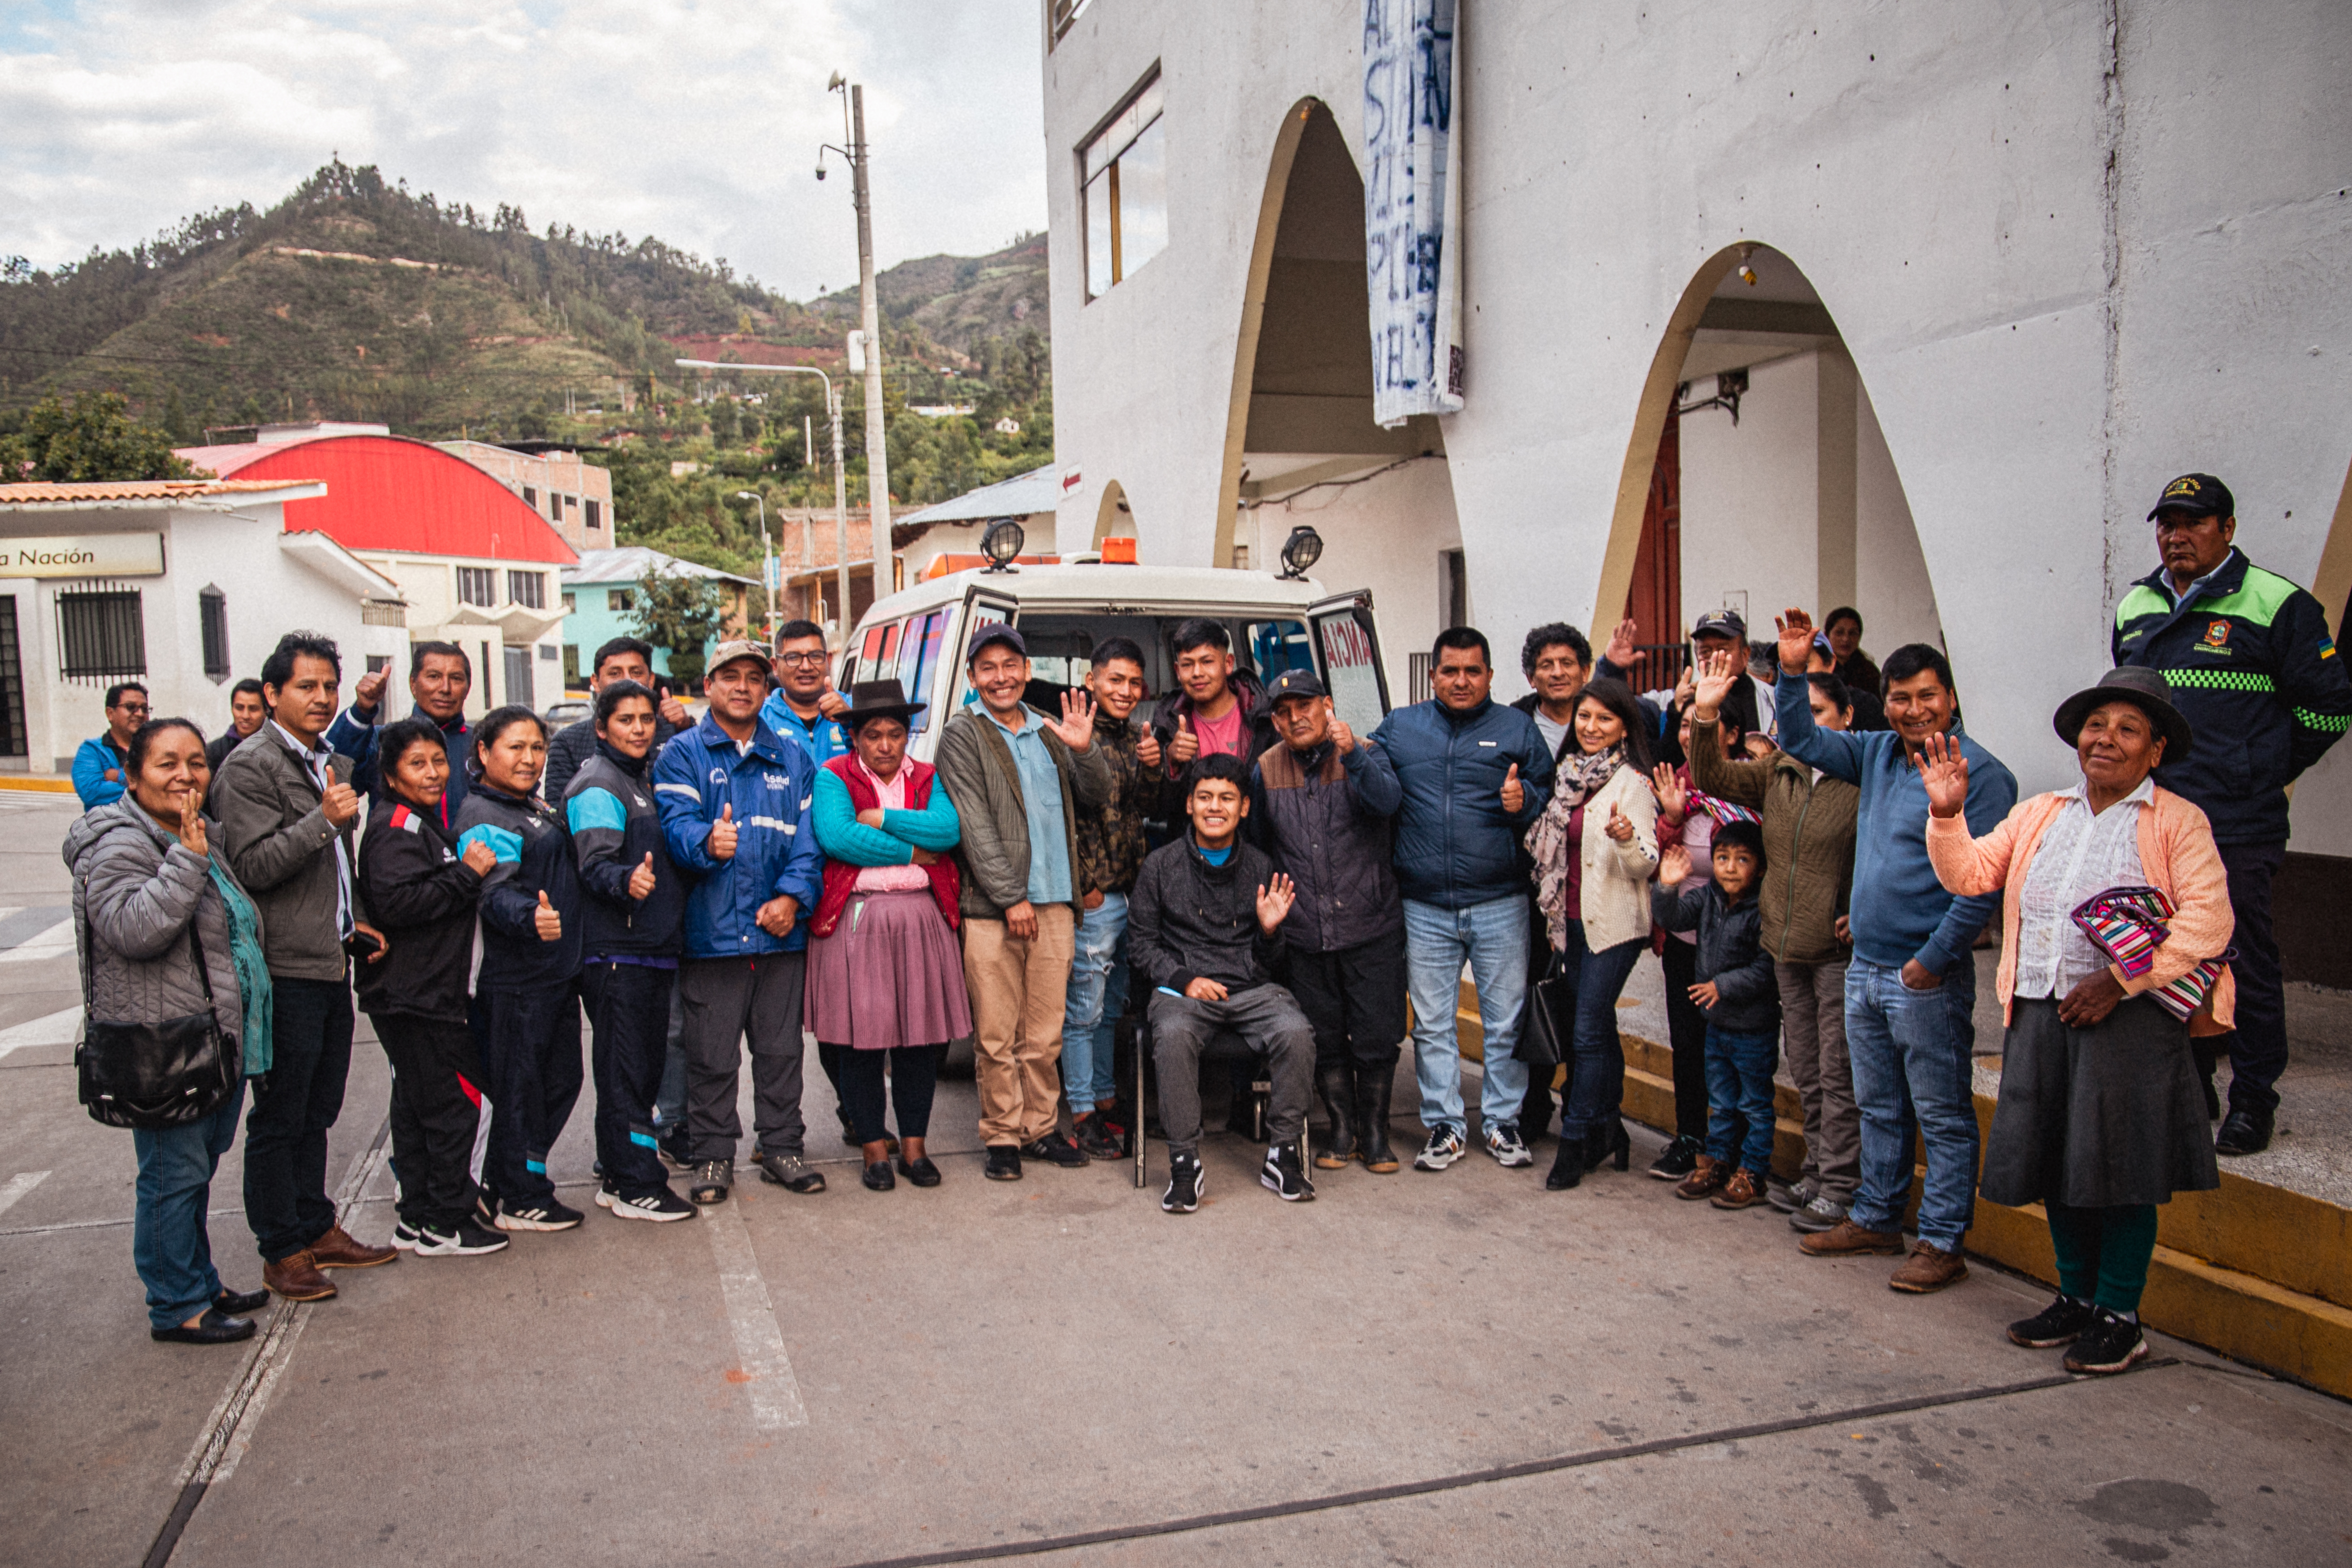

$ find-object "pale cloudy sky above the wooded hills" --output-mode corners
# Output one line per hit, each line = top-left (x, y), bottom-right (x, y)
(0, 0), (1044, 298)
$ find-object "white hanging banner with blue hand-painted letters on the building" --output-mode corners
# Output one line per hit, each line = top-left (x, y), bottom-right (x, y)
(1364, 0), (1463, 428)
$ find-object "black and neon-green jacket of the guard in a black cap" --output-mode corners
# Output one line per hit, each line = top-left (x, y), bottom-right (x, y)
(2114, 548), (2352, 844)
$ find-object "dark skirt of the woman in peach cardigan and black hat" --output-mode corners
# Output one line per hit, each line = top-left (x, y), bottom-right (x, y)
(1978, 997), (2220, 1208)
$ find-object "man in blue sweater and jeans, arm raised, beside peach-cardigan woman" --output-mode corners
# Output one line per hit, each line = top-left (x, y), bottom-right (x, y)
(1773, 609), (2018, 1295)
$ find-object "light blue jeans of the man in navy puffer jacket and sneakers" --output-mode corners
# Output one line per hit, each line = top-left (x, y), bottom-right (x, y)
(1404, 893), (1527, 1133)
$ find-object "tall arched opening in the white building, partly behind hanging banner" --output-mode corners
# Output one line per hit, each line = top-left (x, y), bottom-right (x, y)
(1209, 99), (1468, 694)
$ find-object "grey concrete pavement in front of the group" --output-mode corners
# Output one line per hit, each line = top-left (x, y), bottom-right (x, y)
(0, 806), (2352, 1566)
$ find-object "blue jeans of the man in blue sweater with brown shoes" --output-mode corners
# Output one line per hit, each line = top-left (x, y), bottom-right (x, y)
(1846, 957), (1978, 1251)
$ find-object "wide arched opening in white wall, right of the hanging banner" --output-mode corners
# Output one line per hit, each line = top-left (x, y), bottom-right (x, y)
(1593, 242), (1943, 700)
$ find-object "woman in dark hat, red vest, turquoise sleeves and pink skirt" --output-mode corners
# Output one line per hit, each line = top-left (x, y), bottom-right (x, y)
(807, 679), (971, 1192)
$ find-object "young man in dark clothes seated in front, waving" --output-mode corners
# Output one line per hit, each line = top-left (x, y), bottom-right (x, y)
(1126, 755), (1315, 1213)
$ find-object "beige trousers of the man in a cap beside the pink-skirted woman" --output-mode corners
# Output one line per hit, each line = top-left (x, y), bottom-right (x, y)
(964, 903), (1075, 1145)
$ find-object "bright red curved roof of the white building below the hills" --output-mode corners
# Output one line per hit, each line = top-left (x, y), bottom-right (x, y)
(179, 435), (579, 567)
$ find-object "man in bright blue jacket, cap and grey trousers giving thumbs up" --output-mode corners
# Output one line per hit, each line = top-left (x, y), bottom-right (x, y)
(654, 639), (825, 1204)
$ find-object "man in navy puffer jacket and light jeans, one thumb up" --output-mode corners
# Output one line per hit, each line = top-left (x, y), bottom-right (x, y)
(1371, 625), (1552, 1171)
